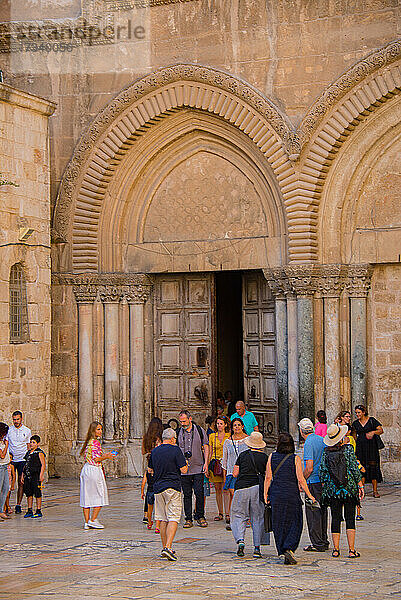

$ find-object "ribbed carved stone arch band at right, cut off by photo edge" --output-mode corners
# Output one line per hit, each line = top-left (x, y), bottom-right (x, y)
(284, 40), (401, 263)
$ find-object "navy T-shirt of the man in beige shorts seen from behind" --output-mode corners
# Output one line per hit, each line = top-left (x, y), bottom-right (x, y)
(149, 444), (187, 494)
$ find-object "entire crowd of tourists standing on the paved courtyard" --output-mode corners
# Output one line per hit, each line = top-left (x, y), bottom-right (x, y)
(0, 401), (383, 565)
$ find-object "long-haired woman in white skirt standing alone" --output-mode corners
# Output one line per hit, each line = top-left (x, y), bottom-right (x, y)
(79, 421), (115, 529)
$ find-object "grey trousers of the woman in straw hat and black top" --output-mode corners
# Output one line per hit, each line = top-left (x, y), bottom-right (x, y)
(230, 485), (270, 546)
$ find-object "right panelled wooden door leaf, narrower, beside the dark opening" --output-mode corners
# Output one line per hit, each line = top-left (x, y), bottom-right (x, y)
(242, 272), (278, 444)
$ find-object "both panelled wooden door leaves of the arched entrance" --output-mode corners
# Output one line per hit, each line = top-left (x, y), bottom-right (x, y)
(154, 271), (278, 443)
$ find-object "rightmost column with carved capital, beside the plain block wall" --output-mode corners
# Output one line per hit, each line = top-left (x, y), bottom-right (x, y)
(347, 265), (372, 410)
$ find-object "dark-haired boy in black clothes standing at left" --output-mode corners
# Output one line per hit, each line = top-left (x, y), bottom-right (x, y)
(22, 435), (46, 519)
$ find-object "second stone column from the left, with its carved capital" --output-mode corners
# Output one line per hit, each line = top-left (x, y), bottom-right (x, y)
(100, 285), (121, 441)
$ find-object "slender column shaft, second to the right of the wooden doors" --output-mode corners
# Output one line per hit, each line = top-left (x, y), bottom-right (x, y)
(287, 295), (299, 442)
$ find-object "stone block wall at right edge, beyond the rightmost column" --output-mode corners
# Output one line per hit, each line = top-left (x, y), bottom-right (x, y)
(368, 264), (401, 481)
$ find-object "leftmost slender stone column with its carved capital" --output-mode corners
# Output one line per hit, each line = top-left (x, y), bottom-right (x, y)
(73, 285), (96, 440)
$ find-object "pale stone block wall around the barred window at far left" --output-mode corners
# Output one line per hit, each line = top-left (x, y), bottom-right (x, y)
(0, 83), (54, 460)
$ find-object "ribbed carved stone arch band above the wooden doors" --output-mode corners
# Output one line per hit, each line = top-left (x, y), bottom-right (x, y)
(54, 65), (294, 272)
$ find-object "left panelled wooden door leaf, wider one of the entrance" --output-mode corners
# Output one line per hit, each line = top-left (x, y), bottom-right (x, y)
(154, 273), (214, 424)
